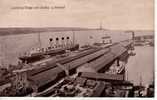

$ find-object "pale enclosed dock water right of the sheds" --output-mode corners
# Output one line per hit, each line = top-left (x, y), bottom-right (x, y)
(126, 46), (154, 85)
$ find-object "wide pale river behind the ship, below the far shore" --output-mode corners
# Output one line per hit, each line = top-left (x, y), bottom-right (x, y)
(0, 30), (131, 65)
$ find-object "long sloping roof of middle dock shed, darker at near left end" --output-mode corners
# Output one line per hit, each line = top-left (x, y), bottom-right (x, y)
(29, 50), (106, 87)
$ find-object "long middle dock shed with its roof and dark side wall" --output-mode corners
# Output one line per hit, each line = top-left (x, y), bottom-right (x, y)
(29, 47), (106, 91)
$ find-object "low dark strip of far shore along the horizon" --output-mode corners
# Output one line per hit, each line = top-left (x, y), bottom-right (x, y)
(0, 27), (154, 36)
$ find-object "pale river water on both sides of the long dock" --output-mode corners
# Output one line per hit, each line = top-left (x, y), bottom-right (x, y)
(0, 30), (154, 84)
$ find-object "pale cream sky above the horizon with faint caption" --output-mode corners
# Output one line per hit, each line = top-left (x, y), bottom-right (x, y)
(0, 0), (154, 30)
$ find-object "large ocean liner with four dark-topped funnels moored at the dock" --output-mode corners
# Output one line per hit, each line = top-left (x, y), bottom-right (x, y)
(19, 32), (79, 63)
